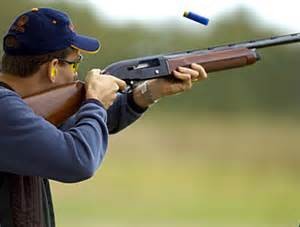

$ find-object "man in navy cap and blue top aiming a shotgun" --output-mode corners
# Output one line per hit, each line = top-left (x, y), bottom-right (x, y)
(0, 8), (206, 227)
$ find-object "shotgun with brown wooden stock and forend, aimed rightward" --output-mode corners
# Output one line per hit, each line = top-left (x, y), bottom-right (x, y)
(23, 33), (300, 126)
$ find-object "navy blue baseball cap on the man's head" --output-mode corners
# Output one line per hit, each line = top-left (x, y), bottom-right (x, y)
(3, 8), (100, 55)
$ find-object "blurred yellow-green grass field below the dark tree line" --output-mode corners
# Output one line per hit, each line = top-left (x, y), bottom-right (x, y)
(52, 114), (300, 227)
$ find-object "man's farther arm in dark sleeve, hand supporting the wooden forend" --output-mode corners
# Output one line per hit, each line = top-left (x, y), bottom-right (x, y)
(107, 64), (207, 133)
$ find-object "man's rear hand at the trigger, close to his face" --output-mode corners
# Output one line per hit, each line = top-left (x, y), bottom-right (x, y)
(85, 69), (126, 109)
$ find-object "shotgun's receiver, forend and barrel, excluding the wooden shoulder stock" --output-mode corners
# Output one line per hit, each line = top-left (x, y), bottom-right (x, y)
(105, 33), (300, 82)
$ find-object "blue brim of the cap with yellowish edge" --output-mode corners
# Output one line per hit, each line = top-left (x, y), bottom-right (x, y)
(71, 35), (101, 54)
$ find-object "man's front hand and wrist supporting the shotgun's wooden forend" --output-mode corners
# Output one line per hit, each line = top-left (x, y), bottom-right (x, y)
(133, 64), (207, 108)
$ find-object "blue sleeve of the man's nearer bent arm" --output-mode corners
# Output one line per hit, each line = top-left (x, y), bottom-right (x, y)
(0, 89), (108, 182)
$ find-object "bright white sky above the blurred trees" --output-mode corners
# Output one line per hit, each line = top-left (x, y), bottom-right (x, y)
(85, 0), (300, 32)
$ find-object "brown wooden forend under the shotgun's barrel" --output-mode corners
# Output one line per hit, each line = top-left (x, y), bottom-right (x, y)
(167, 48), (259, 72)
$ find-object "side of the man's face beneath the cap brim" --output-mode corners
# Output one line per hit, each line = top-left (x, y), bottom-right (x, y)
(55, 50), (81, 85)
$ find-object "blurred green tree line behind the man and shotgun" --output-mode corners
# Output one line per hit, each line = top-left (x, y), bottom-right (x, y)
(0, 0), (300, 116)
